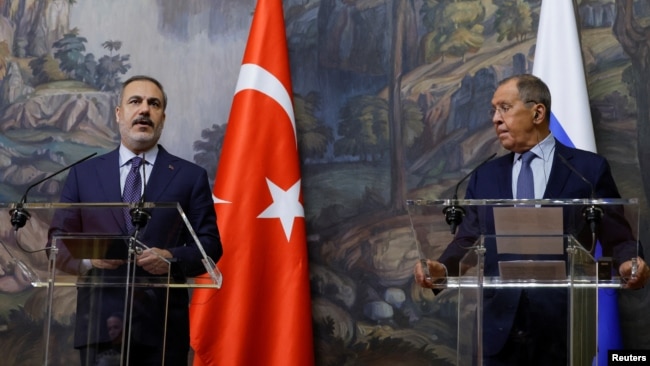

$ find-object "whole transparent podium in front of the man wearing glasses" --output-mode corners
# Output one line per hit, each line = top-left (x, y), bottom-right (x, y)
(407, 199), (640, 365)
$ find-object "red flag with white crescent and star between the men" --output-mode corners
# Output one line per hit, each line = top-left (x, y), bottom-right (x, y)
(190, 0), (314, 366)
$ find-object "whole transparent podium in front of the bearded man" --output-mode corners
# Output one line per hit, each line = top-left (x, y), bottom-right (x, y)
(0, 202), (223, 365)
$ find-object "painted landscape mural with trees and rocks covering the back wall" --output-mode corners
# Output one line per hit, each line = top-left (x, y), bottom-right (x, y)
(0, 0), (650, 365)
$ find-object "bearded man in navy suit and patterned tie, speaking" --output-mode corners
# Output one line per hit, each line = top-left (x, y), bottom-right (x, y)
(51, 76), (222, 365)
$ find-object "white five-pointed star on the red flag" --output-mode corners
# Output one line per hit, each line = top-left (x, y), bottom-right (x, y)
(257, 178), (305, 241)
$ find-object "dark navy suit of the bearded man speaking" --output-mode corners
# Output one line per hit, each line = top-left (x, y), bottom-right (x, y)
(46, 146), (222, 356)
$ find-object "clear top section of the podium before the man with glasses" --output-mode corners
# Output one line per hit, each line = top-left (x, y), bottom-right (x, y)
(407, 198), (640, 288)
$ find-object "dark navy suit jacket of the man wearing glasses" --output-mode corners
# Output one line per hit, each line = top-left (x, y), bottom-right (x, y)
(439, 141), (640, 355)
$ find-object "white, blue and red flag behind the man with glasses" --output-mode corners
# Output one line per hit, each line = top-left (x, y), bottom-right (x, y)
(533, 0), (622, 365)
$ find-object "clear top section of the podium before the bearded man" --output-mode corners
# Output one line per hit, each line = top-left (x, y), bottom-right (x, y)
(0, 202), (223, 288)
